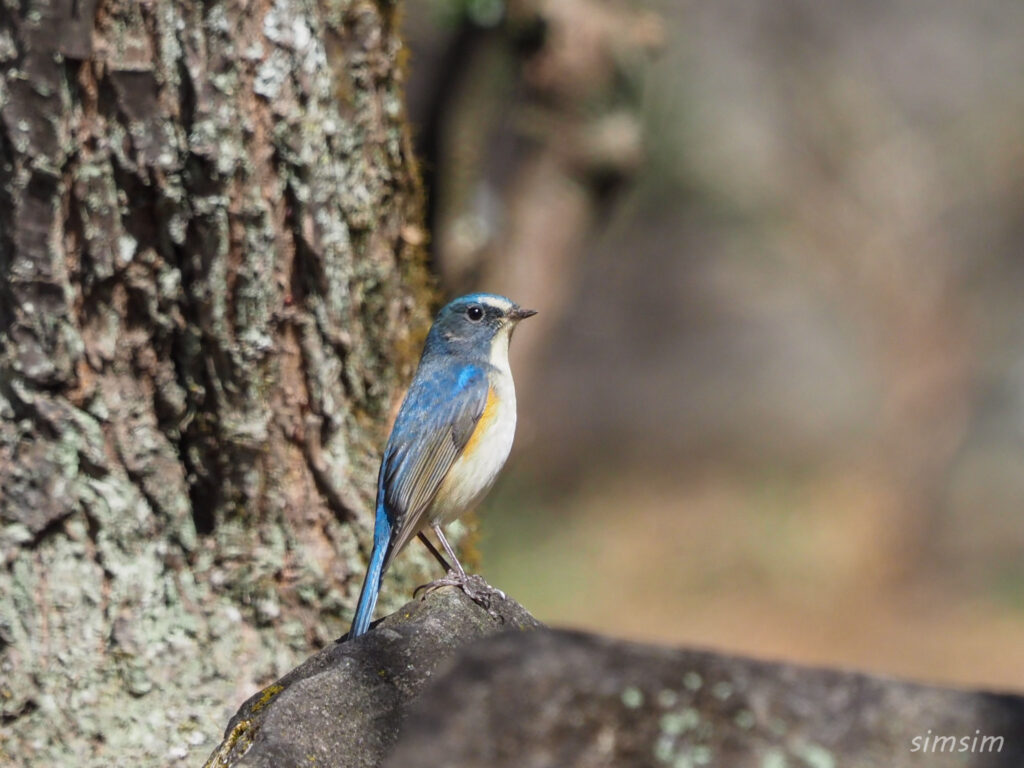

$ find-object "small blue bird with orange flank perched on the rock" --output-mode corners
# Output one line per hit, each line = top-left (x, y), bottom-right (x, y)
(348, 293), (537, 639)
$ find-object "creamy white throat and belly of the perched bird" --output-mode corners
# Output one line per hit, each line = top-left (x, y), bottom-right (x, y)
(429, 333), (516, 524)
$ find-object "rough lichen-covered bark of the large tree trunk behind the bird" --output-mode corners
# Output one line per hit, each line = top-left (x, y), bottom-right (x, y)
(0, 0), (431, 765)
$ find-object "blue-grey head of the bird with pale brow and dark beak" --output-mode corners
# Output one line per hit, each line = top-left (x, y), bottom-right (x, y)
(426, 293), (537, 359)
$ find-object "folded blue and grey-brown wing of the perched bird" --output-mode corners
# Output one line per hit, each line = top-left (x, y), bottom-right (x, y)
(377, 359), (490, 572)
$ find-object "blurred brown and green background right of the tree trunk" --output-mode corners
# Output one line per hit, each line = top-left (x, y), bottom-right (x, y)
(403, 0), (1024, 690)
